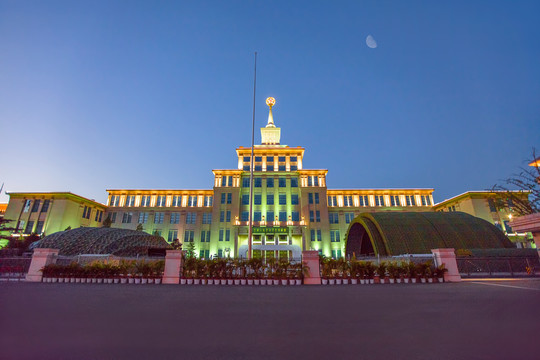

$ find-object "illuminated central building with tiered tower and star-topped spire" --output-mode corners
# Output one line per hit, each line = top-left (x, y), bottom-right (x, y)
(106, 98), (433, 258)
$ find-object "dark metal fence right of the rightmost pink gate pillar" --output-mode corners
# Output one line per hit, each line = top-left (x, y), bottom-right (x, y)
(456, 257), (540, 278)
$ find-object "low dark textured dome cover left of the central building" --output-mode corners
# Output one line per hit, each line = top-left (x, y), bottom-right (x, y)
(31, 227), (169, 256)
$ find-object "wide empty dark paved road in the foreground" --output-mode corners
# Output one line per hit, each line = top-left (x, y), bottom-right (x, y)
(0, 281), (540, 359)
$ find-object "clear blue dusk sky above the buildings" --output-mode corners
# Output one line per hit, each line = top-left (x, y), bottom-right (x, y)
(0, 0), (540, 202)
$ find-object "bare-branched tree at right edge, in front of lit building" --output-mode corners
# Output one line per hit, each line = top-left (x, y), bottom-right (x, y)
(491, 148), (540, 216)
